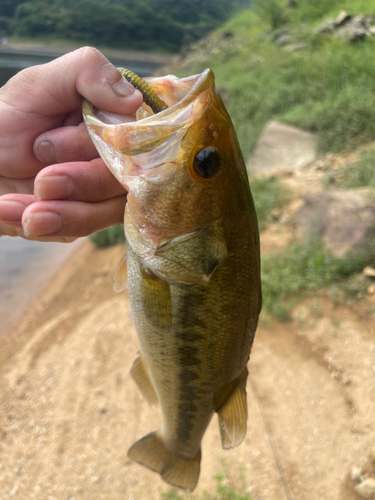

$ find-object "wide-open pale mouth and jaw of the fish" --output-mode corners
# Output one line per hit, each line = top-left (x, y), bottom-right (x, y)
(82, 69), (215, 190)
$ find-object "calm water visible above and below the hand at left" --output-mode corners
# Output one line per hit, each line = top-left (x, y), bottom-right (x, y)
(0, 49), (157, 335)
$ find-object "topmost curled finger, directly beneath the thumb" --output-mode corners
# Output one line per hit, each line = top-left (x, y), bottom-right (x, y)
(34, 123), (99, 164)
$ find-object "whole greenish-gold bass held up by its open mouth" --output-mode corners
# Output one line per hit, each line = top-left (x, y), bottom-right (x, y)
(83, 69), (262, 491)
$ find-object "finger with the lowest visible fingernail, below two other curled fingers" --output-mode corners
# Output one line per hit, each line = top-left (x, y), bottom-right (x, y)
(22, 195), (126, 238)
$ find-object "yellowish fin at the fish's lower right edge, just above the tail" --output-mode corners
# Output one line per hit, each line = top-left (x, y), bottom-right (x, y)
(216, 368), (248, 449)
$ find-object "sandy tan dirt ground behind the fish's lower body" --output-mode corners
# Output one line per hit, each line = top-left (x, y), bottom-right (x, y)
(0, 219), (375, 500)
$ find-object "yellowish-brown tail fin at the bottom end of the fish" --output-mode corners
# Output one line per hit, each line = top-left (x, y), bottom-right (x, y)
(128, 431), (201, 491)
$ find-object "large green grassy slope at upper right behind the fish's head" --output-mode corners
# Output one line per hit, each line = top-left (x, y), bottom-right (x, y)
(169, 0), (375, 158)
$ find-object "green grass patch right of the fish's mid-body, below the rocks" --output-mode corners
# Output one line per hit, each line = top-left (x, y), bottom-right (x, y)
(262, 242), (375, 321)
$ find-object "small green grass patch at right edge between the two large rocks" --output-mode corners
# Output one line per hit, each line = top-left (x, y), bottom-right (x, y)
(326, 147), (375, 189)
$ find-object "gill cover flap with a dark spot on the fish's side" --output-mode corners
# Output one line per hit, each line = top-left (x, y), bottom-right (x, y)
(155, 221), (228, 286)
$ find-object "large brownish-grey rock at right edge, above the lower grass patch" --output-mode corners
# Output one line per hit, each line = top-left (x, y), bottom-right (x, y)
(294, 189), (375, 258)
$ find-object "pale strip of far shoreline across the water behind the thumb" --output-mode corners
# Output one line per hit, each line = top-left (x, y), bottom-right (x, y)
(0, 42), (174, 65)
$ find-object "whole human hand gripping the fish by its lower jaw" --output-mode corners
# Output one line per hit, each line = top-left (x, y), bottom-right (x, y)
(0, 47), (142, 242)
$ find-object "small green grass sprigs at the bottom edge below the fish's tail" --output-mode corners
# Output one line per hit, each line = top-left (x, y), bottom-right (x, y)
(160, 460), (253, 500)
